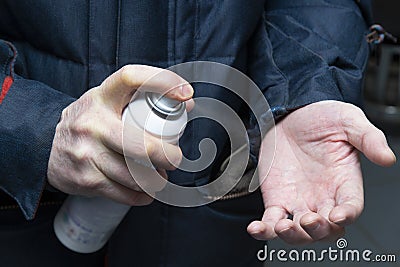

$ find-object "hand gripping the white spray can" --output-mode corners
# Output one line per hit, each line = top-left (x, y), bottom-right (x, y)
(47, 65), (193, 205)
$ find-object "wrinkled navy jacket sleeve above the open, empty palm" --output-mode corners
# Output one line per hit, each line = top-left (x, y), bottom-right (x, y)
(264, 0), (369, 117)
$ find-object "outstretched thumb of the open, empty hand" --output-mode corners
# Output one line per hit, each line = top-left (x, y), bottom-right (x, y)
(341, 104), (396, 167)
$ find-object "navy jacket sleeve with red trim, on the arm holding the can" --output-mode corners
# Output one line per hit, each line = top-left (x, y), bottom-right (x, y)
(0, 40), (74, 219)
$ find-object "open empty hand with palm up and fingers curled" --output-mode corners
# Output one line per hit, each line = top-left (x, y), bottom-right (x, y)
(248, 101), (396, 244)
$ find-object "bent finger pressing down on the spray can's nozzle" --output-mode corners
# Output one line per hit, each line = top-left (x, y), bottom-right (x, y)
(99, 65), (193, 114)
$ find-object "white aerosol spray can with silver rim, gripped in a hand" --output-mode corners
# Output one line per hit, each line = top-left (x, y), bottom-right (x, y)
(54, 92), (187, 253)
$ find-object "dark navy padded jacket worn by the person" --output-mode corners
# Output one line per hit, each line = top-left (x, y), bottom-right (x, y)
(0, 0), (369, 219)
